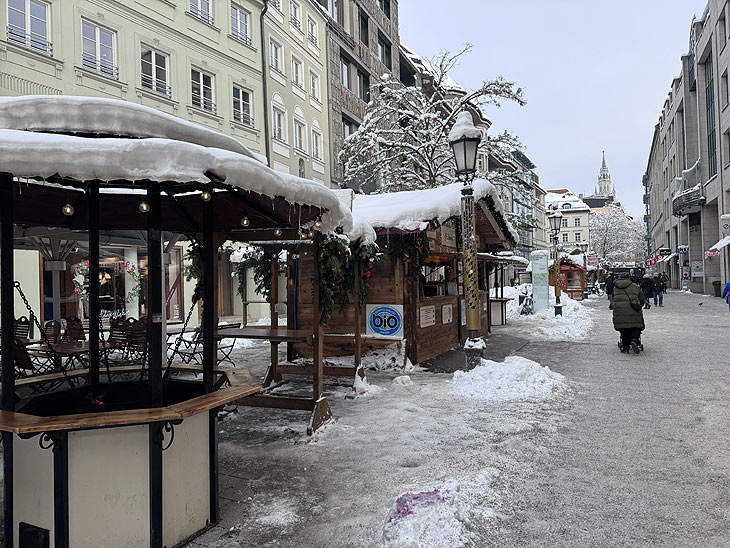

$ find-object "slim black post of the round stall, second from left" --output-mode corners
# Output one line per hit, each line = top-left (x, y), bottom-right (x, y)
(86, 181), (101, 386)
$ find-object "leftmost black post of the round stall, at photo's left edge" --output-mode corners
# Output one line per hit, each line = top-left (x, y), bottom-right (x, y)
(0, 173), (15, 548)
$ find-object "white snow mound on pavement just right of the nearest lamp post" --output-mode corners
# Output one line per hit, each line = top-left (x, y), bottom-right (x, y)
(451, 356), (565, 401)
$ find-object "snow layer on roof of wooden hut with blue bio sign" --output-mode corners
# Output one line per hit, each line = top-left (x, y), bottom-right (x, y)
(352, 179), (519, 242)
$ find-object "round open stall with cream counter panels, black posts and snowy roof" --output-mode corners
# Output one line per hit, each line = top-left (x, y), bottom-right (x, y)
(0, 96), (349, 548)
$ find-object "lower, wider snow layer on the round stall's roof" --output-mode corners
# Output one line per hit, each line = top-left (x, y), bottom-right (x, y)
(0, 97), (352, 231)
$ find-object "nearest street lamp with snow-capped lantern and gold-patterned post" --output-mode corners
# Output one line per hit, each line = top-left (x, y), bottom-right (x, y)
(449, 111), (485, 370)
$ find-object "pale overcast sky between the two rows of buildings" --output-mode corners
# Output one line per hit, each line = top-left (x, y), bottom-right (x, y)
(399, 0), (707, 216)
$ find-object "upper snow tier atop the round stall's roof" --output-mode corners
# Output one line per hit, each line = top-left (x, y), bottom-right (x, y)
(0, 95), (266, 163)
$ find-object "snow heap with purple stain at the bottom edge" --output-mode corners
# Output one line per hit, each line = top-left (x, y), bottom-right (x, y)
(382, 468), (499, 548)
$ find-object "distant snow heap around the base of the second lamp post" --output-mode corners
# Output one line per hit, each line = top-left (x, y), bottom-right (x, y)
(492, 284), (593, 341)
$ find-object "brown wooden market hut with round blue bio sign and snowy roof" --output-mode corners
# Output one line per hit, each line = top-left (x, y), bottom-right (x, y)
(290, 180), (518, 363)
